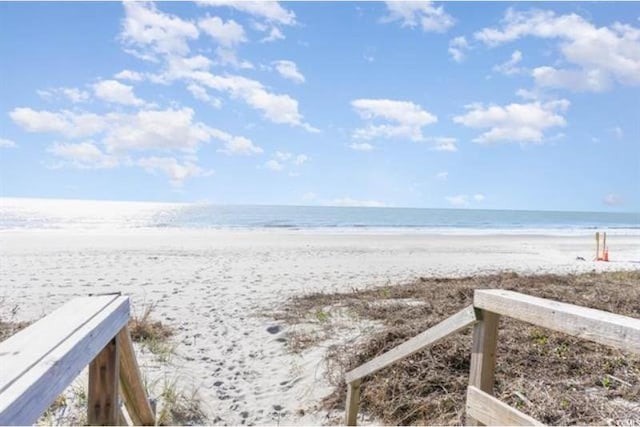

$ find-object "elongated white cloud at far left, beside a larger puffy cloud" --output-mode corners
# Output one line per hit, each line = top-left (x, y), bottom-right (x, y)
(9, 107), (106, 137)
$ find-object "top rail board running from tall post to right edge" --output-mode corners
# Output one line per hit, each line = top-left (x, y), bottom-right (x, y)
(473, 289), (640, 353)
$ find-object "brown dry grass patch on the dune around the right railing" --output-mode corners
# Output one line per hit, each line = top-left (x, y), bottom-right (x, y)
(281, 271), (640, 425)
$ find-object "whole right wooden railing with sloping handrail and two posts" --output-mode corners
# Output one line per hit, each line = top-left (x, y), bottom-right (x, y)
(345, 289), (640, 426)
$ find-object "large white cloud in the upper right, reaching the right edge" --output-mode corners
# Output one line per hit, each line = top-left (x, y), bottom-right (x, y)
(475, 9), (640, 92)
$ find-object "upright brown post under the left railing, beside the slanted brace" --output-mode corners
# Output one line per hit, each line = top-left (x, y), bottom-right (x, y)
(87, 337), (120, 425)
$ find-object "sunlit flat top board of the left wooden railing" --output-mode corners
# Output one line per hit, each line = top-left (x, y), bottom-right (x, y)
(0, 295), (118, 393)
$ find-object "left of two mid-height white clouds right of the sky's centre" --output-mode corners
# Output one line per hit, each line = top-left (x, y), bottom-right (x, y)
(351, 99), (438, 141)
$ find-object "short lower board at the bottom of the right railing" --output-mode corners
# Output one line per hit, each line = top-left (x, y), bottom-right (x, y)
(466, 386), (544, 426)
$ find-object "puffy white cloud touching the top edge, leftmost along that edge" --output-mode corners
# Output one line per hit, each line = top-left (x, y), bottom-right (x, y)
(120, 2), (199, 60)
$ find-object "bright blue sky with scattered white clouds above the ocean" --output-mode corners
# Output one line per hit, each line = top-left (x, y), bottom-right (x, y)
(0, 1), (640, 212)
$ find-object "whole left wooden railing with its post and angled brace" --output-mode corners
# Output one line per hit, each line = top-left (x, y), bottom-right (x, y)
(0, 294), (155, 425)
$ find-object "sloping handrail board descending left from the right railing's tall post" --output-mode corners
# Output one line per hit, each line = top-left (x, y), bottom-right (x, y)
(345, 306), (476, 383)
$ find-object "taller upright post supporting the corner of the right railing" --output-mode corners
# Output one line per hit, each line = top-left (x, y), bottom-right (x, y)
(467, 310), (500, 426)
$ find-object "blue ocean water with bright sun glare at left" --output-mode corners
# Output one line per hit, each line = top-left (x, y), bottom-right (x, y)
(0, 198), (640, 235)
